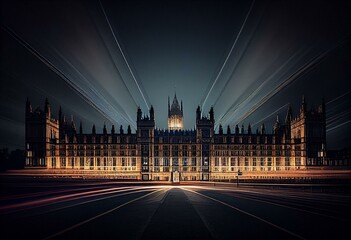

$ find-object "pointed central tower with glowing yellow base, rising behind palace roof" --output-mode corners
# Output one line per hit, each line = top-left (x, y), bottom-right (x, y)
(168, 94), (183, 130)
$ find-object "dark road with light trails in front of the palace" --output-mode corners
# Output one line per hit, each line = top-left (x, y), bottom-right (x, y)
(0, 182), (351, 239)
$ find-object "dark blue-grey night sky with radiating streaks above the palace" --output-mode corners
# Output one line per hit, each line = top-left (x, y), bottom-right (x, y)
(0, 0), (351, 149)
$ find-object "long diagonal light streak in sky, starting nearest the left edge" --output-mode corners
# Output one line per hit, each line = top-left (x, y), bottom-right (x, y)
(1, 25), (134, 125)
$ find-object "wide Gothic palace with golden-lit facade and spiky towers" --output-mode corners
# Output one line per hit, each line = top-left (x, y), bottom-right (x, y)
(25, 96), (326, 181)
